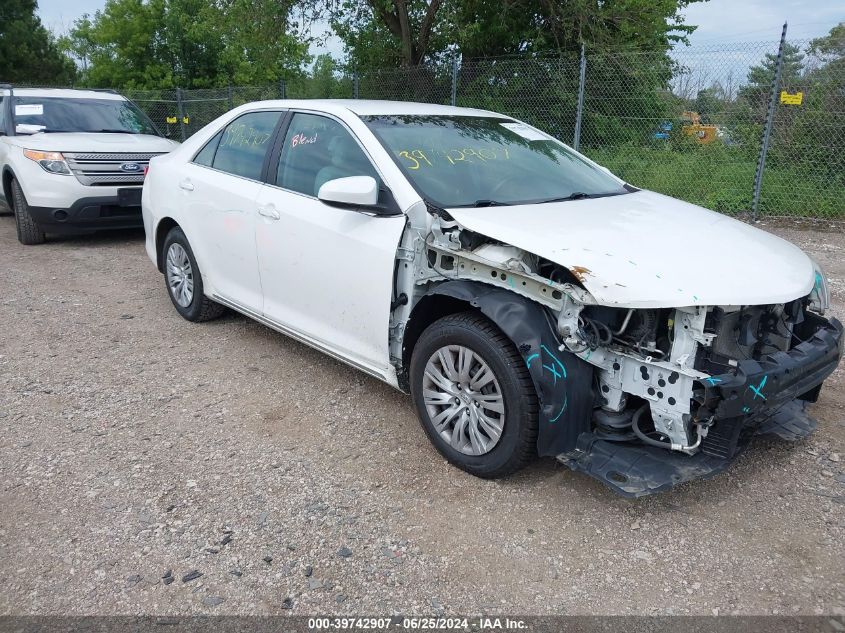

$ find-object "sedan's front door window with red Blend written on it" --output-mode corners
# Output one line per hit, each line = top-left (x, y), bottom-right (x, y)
(276, 113), (379, 196)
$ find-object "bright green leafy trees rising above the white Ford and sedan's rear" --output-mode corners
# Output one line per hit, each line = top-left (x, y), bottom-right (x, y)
(62, 0), (308, 88)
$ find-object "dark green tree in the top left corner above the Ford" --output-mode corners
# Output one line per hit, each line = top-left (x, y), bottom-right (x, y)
(0, 0), (76, 85)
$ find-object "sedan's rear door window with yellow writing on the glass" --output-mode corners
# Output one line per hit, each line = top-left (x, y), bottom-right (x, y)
(212, 112), (281, 180)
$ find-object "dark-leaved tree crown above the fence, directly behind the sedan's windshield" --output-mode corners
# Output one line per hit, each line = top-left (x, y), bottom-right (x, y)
(324, 0), (701, 69)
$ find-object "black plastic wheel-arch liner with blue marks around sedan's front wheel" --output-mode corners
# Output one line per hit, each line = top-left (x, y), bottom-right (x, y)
(428, 280), (594, 457)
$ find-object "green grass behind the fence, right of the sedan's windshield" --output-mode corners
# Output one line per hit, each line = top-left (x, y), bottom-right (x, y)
(582, 145), (845, 219)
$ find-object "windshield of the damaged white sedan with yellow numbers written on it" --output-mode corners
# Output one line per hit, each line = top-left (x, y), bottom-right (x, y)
(363, 115), (630, 208)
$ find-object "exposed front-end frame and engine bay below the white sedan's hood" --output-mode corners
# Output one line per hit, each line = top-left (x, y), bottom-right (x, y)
(390, 205), (842, 496)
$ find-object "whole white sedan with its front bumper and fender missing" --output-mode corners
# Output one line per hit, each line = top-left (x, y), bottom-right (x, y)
(143, 101), (842, 496)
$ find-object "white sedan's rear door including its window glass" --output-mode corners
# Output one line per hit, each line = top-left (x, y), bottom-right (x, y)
(178, 111), (283, 313)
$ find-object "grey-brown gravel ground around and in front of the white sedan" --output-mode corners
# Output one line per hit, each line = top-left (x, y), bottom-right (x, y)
(0, 217), (845, 615)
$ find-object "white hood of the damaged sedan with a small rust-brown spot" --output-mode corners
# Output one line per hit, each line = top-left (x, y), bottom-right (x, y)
(448, 191), (815, 308)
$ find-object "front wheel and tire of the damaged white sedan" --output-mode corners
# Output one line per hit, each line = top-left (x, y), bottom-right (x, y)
(410, 312), (538, 479)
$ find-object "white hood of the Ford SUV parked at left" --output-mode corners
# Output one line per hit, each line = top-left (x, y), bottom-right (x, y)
(10, 132), (179, 153)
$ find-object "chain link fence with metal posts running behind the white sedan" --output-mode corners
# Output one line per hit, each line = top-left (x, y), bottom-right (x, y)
(11, 31), (845, 220)
